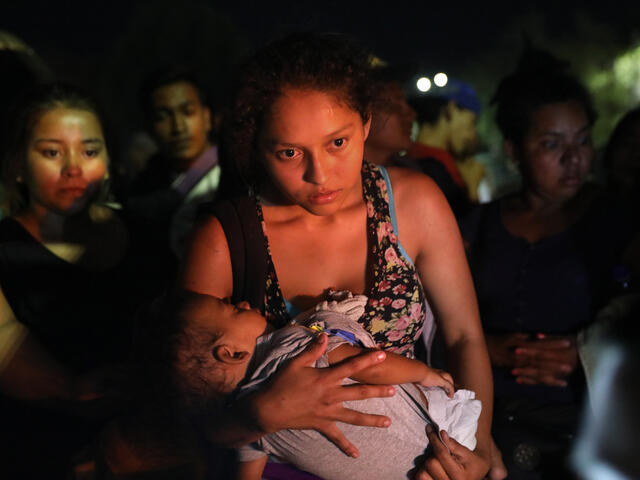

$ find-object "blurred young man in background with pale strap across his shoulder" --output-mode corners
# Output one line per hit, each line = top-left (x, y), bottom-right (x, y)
(123, 67), (221, 290)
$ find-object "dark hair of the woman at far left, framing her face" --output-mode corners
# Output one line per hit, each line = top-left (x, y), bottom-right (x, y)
(2, 83), (109, 214)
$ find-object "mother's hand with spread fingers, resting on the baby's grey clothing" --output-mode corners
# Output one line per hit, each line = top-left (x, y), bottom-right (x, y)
(251, 334), (395, 458)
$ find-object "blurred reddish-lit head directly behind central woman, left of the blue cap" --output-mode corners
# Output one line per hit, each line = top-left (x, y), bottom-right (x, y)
(364, 66), (416, 166)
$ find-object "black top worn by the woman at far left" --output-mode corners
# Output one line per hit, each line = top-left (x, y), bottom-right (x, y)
(0, 218), (136, 373)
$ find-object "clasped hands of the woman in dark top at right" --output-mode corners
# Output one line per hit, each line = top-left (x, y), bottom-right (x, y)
(511, 333), (578, 387)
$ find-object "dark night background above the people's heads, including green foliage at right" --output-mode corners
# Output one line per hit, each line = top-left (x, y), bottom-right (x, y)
(0, 0), (640, 163)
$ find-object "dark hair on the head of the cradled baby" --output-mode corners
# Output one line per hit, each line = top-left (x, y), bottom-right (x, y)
(135, 290), (231, 416)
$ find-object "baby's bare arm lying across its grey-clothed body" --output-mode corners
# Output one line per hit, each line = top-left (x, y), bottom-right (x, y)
(328, 343), (454, 397)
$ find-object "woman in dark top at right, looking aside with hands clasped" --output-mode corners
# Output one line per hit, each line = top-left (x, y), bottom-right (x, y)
(461, 49), (632, 479)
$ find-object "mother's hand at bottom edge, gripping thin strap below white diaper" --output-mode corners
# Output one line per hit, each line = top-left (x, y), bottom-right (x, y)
(414, 425), (490, 480)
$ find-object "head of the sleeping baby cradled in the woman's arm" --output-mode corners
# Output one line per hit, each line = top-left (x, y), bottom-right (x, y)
(135, 291), (266, 413)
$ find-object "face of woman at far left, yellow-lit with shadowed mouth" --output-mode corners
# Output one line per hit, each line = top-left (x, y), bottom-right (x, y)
(23, 107), (108, 214)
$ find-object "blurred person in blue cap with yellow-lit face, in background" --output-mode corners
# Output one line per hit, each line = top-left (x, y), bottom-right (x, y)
(399, 79), (480, 218)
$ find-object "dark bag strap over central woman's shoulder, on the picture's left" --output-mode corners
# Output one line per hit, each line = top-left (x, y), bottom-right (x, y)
(201, 195), (267, 313)
